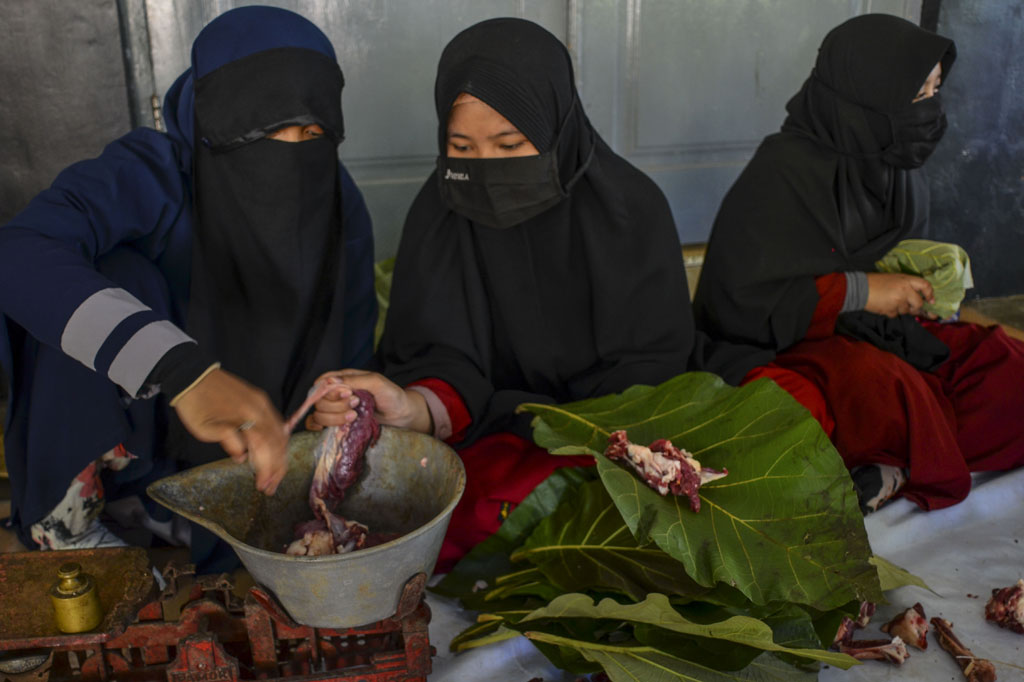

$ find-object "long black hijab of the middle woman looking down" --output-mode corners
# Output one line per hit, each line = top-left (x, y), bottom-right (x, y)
(380, 18), (694, 442)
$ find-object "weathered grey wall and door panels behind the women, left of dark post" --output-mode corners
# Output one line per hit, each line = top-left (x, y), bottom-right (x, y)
(0, 0), (920, 257)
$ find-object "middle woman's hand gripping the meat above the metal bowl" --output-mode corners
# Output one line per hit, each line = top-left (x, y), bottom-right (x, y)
(306, 370), (431, 433)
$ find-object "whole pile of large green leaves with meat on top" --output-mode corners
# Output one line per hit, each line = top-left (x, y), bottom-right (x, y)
(434, 373), (920, 682)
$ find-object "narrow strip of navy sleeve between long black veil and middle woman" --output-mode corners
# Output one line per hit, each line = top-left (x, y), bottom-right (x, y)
(338, 164), (377, 369)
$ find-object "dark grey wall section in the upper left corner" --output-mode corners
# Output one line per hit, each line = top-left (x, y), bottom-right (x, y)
(0, 0), (130, 224)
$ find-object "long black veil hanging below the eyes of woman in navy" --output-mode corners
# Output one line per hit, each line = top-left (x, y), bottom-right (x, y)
(188, 133), (341, 411)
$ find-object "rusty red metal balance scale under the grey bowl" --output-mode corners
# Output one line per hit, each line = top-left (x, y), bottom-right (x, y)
(0, 548), (434, 682)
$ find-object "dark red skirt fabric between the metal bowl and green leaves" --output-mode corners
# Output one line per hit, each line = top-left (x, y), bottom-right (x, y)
(434, 433), (594, 572)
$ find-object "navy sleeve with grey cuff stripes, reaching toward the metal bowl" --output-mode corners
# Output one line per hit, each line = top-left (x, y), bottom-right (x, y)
(0, 129), (187, 394)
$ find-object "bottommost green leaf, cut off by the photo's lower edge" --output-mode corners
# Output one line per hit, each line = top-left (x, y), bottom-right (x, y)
(525, 631), (817, 682)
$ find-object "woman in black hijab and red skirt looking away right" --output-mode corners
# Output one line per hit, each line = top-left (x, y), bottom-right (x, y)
(694, 14), (1024, 511)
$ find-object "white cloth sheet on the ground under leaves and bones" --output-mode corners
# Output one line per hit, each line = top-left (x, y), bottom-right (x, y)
(427, 469), (1024, 682)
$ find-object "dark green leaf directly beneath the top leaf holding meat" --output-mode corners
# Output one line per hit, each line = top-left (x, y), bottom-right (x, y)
(512, 480), (724, 600)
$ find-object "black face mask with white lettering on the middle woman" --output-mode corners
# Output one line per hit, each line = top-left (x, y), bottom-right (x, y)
(437, 151), (568, 228)
